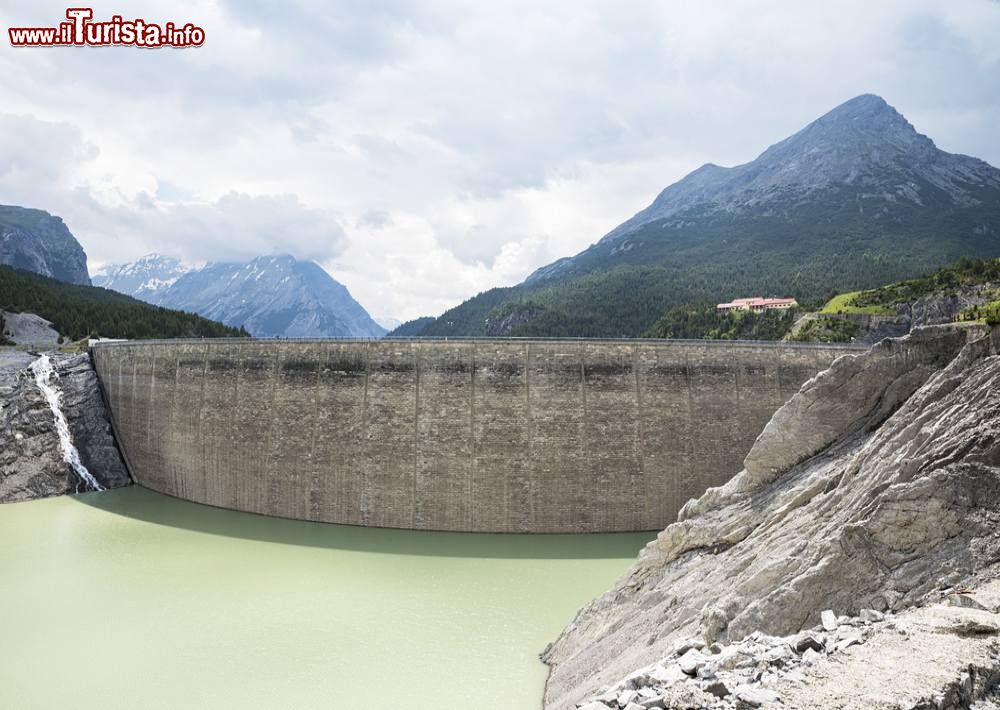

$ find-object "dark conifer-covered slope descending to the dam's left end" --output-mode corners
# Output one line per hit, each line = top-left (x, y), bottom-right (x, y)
(0, 266), (249, 340)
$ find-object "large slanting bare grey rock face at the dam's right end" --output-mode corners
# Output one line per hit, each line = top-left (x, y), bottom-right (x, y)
(543, 327), (1000, 710)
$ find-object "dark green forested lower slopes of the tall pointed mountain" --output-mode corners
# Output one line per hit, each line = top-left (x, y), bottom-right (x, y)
(410, 185), (1000, 337)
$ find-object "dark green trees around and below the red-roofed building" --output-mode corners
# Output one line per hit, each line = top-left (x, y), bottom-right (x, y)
(643, 304), (798, 340)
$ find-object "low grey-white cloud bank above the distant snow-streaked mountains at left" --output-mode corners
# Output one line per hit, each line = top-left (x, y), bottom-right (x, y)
(0, 114), (346, 270)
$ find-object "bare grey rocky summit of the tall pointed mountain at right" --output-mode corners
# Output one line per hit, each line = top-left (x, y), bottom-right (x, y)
(592, 94), (1000, 248)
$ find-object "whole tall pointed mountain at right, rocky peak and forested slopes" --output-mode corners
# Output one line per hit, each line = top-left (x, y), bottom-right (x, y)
(410, 94), (1000, 337)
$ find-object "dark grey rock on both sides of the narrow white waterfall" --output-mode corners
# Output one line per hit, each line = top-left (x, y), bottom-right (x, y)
(0, 352), (129, 502)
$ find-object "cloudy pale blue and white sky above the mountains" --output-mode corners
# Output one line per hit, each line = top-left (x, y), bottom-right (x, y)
(0, 0), (1000, 320)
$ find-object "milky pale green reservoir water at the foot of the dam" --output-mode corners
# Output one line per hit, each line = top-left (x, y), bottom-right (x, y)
(0, 487), (652, 710)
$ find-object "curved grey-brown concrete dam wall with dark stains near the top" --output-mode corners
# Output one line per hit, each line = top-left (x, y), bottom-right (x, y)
(92, 340), (851, 533)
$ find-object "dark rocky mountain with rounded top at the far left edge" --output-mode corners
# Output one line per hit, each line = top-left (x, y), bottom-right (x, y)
(0, 205), (90, 286)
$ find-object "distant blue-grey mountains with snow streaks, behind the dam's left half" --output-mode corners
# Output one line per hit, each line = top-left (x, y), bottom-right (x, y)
(99, 254), (386, 338)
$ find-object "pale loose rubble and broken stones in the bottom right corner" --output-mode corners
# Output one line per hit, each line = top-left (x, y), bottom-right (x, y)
(568, 582), (1000, 710)
